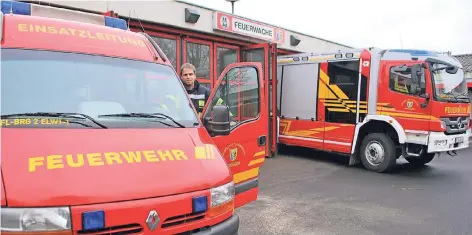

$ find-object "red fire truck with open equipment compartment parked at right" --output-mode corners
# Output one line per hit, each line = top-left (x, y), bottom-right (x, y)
(277, 48), (471, 172)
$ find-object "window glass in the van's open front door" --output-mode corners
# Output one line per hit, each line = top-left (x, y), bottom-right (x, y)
(205, 67), (260, 127)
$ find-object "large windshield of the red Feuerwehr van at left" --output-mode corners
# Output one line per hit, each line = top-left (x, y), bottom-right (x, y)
(1, 49), (198, 128)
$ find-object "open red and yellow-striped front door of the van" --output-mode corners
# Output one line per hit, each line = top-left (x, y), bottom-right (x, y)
(202, 62), (269, 208)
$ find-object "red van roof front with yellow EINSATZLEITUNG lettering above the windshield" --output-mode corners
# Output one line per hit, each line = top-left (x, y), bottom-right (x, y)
(1, 13), (161, 64)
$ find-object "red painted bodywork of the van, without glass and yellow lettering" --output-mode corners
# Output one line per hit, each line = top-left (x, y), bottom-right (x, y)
(0, 9), (268, 234)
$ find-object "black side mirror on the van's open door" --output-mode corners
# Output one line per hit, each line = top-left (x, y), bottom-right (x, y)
(204, 105), (231, 136)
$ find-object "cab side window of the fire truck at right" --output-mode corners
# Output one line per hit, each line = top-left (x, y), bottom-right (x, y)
(389, 65), (426, 95)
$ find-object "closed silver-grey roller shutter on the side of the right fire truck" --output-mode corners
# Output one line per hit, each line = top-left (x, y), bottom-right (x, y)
(281, 63), (319, 120)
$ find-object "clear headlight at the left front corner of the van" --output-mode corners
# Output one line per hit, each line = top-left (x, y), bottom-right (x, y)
(0, 207), (71, 232)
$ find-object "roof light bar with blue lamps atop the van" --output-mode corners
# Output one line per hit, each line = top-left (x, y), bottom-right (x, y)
(1, 0), (128, 30)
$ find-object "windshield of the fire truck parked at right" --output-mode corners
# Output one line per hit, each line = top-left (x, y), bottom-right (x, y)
(432, 63), (467, 100)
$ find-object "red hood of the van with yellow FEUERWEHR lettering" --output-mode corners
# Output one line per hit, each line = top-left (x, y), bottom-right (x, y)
(1, 128), (231, 206)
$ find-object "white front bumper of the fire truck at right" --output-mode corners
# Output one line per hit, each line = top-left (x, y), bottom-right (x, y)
(428, 129), (471, 153)
